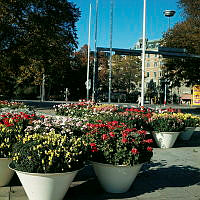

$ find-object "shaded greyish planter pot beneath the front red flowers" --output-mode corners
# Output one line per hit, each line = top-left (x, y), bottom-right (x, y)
(92, 162), (143, 193)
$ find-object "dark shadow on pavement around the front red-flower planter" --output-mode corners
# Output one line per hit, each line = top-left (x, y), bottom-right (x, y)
(64, 160), (200, 200)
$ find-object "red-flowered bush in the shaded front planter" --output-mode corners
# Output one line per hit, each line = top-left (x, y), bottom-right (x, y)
(85, 121), (153, 166)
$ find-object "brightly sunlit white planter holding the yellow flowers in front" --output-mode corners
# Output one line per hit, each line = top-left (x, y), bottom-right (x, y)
(9, 167), (78, 200)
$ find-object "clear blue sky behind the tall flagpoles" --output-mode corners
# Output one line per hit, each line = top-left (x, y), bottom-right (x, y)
(69, 0), (182, 50)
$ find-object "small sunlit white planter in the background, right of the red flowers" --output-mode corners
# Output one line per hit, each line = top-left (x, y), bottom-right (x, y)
(153, 132), (180, 149)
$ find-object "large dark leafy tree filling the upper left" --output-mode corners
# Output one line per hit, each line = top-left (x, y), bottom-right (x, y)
(0, 0), (80, 99)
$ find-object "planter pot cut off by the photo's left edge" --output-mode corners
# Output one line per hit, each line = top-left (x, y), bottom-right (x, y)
(0, 158), (14, 186)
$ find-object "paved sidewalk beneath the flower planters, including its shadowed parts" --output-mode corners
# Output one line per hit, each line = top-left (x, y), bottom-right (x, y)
(0, 132), (200, 200)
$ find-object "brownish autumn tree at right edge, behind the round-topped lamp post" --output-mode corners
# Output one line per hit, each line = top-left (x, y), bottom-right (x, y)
(163, 0), (200, 86)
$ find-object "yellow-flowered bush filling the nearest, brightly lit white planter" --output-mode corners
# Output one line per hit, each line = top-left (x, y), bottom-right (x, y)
(11, 130), (85, 173)
